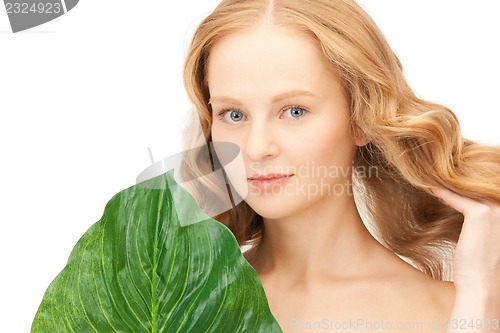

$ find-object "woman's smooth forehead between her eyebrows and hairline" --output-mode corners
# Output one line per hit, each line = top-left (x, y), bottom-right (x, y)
(207, 24), (334, 98)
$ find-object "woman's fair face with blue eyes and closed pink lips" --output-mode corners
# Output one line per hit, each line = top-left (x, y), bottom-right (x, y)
(207, 24), (364, 219)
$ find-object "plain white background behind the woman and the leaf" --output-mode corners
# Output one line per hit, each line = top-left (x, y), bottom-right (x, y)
(0, 0), (500, 333)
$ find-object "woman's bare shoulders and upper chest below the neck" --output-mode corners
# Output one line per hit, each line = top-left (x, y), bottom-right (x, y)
(245, 233), (455, 333)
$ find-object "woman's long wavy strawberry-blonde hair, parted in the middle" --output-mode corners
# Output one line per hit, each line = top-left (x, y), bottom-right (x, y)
(182, 0), (500, 280)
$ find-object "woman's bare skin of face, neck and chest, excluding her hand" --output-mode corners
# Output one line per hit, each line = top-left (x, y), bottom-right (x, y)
(207, 23), (455, 333)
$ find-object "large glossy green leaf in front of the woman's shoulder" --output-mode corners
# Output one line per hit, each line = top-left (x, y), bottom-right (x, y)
(31, 173), (281, 333)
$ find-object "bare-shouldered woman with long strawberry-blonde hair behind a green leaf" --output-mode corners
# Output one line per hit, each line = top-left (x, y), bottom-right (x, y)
(184, 0), (500, 332)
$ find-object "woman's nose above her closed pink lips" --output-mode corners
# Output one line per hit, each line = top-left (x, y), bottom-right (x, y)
(245, 122), (279, 161)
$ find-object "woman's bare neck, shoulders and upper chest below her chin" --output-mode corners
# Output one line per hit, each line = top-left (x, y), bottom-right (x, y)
(245, 192), (455, 333)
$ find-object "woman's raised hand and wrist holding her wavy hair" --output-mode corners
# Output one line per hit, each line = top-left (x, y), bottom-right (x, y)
(432, 188), (500, 332)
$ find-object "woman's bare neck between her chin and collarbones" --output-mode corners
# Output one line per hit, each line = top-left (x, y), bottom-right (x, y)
(249, 196), (381, 283)
